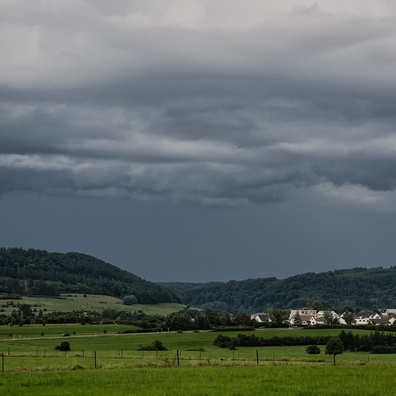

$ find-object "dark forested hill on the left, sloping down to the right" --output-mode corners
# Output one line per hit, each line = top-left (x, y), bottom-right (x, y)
(0, 248), (179, 304)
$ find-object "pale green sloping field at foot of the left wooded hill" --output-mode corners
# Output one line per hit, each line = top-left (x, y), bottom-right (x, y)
(0, 293), (185, 315)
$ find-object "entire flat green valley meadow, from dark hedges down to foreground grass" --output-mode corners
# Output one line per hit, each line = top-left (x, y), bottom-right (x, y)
(0, 325), (396, 396)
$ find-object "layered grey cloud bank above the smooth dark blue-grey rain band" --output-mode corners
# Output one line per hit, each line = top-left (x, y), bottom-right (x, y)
(0, 0), (396, 207)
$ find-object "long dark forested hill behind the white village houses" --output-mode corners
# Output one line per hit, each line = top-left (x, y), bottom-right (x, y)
(160, 267), (396, 312)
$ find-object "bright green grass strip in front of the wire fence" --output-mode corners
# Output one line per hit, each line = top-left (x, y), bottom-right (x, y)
(0, 366), (396, 396)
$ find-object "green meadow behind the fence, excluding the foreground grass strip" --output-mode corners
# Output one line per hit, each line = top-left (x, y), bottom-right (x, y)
(0, 324), (396, 370)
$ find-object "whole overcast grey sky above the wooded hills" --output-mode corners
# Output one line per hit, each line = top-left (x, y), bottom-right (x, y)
(0, 0), (396, 282)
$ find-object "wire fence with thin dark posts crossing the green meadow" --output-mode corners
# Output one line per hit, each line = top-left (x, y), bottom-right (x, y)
(0, 348), (327, 373)
